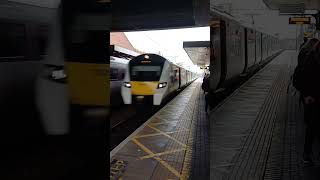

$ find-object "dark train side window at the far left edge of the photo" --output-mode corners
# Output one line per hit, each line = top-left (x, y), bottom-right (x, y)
(0, 22), (27, 60)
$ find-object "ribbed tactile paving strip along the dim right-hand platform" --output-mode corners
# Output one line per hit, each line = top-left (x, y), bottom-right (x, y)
(227, 65), (286, 180)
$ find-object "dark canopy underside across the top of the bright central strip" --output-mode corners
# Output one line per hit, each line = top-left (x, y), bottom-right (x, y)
(111, 0), (210, 32)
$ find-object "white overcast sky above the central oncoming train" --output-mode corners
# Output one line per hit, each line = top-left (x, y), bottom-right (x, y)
(125, 27), (210, 71)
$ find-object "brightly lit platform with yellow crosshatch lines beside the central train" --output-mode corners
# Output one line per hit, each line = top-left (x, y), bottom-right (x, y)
(110, 79), (209, 180)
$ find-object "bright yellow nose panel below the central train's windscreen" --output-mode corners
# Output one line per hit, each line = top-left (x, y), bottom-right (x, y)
(130, 81), (159, 96)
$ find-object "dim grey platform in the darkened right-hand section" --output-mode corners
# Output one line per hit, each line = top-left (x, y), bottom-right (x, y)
(210, 51), (320, 180)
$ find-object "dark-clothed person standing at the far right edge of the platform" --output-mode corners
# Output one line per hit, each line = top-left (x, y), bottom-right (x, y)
(293, 38), (320, 165)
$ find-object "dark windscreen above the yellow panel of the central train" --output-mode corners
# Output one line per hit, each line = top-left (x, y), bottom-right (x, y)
(131, 65), (161, 81)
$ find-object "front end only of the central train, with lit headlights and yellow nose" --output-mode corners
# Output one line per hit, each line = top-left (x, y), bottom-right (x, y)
(121, 54), (168, 105)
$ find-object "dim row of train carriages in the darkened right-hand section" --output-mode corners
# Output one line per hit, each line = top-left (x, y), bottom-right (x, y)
(209, 10), (282, 93)
